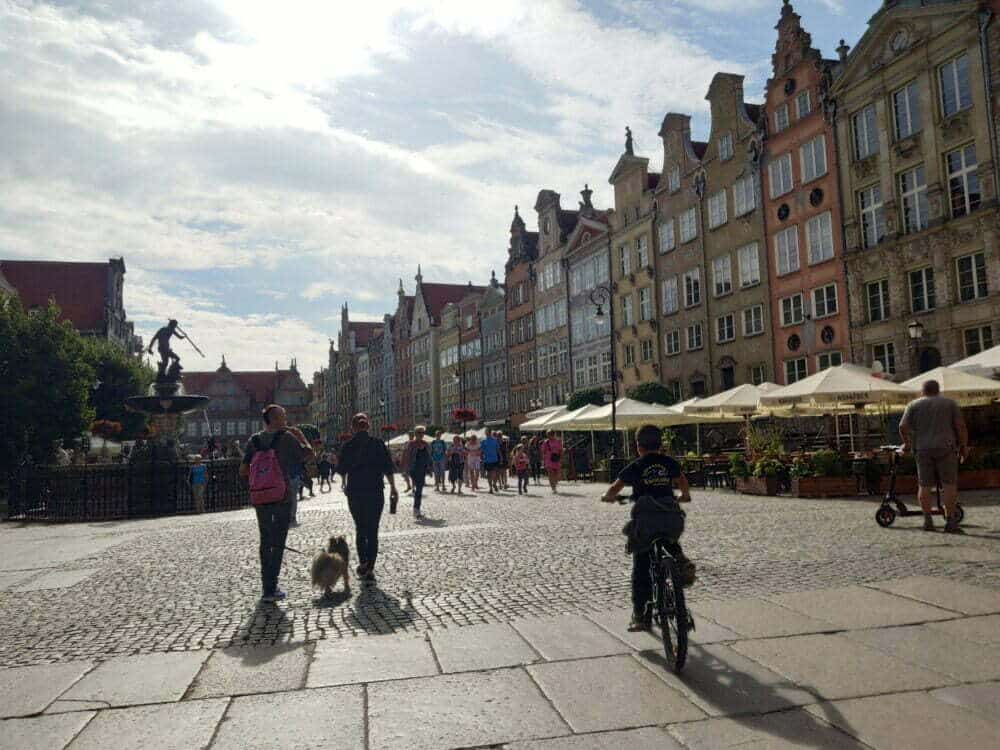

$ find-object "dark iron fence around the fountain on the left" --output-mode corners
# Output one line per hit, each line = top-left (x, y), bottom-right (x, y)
(6, 458), (250, 521)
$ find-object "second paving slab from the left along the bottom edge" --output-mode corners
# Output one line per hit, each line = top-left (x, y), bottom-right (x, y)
(72, 698), (229, 750)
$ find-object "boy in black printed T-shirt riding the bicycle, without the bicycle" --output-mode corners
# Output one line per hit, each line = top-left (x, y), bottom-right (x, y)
(601, 425), (695, 632)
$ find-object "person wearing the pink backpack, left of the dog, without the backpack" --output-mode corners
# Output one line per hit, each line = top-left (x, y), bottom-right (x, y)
(240, 404), (312, 603)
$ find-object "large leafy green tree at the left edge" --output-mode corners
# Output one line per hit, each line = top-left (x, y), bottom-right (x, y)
(0, 297), (94, 471)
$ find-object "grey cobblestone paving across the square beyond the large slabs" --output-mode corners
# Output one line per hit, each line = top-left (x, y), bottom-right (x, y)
(0, 484), (1000, 666)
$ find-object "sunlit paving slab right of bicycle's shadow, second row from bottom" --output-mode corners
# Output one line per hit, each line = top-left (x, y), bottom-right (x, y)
(733, 635), (954, 700)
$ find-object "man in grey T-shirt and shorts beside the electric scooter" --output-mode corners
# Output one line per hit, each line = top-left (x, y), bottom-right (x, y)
(899, 380), (969, 534)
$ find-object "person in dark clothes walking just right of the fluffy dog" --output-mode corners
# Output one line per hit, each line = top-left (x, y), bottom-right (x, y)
(337, 414), (399, 581)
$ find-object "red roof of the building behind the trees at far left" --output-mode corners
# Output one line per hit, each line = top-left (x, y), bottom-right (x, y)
(0, 260), (110, 331)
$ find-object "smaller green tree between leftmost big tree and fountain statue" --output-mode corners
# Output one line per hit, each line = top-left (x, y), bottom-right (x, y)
(84, 339), (156, 440)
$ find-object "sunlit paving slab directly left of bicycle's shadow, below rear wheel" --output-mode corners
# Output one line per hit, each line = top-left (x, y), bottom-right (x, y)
(528, 656), (704, 732)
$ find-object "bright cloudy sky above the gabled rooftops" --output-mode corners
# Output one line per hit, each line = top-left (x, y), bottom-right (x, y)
(0, 0), (880, 381)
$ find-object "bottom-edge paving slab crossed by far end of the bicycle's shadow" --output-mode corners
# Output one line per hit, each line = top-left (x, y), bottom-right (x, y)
(669, 709), (864, 750)
